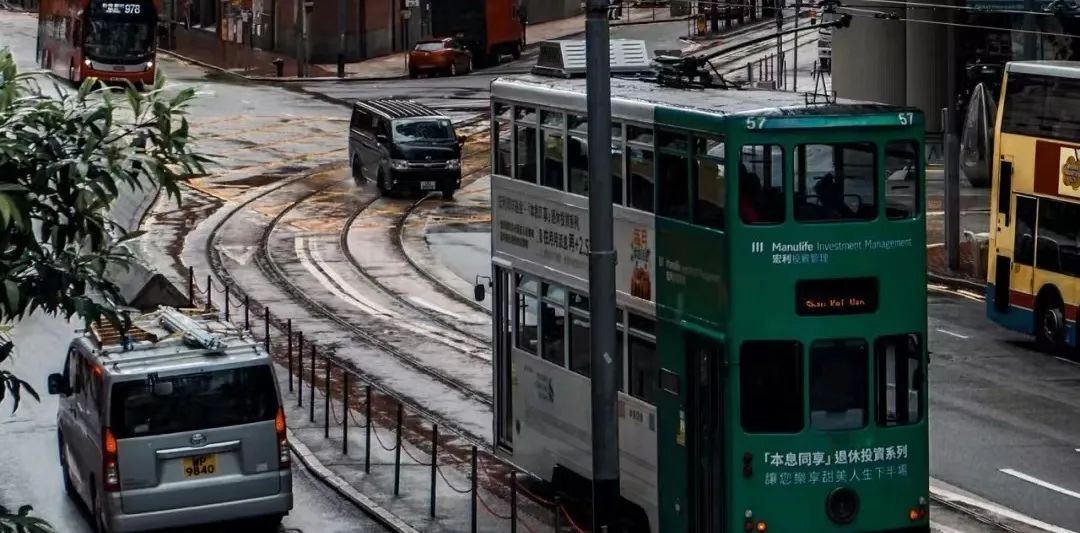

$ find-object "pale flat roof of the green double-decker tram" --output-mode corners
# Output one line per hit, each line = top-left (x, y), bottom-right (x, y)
(491, 74), (919, 122)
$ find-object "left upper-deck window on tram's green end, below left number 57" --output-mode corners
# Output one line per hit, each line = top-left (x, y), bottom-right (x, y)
(739, 145), (784, 224)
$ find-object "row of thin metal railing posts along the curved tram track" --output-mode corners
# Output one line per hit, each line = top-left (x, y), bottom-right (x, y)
(187, 268), (588, 533)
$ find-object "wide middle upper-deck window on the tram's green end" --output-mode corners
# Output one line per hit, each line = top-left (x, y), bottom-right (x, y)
(795, 142), (878, 221)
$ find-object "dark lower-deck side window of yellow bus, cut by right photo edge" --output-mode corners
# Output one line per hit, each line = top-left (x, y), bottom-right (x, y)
(1035, 199), (1080, 276)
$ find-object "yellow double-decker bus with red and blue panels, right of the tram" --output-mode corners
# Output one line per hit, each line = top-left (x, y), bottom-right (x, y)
(986, 62), (1080, 353)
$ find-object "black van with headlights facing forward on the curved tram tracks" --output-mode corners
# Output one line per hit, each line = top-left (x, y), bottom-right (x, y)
(349, 99), (464, 199)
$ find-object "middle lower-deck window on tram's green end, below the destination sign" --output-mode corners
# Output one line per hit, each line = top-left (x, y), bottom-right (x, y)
(810, 339), (869, 431)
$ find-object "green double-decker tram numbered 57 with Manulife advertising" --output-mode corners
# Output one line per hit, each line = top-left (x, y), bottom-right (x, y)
(491, 71), (929, 533)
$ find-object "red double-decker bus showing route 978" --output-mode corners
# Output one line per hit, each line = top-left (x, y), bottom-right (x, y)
(38, 0), (161, 86)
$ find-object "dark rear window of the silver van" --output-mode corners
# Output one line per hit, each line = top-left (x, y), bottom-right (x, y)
(110, 365), (278, 438)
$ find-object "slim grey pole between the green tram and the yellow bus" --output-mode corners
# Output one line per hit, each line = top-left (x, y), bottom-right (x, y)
(942, 0), (960, 272)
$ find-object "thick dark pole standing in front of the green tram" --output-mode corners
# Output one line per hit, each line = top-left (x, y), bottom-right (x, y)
(585, 0), (622, 533)
